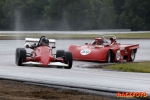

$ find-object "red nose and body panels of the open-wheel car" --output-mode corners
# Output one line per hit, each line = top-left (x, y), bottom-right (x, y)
(26, 45), (63, 66)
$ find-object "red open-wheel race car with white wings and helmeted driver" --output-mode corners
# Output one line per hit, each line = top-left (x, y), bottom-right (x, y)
(15, 36), (72, 69)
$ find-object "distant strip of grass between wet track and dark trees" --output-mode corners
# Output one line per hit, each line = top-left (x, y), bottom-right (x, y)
(0, 33), (150, 40)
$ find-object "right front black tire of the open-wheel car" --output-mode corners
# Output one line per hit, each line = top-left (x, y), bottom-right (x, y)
(64, 52), (73, 69)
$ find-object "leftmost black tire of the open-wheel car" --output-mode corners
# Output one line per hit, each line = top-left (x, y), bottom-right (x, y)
(15, 48), (26, 66)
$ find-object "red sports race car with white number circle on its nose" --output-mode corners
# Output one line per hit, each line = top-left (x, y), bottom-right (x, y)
(69, 35), (139, 63)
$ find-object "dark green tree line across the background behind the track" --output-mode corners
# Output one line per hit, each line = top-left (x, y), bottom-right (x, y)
(0, 0), (150, 31)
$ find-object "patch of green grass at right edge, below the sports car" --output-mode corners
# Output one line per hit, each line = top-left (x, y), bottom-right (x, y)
(105, 61), (150, 73)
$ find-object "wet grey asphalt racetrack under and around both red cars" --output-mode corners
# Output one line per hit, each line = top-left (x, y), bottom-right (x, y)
(0, 39), (150, 98)
